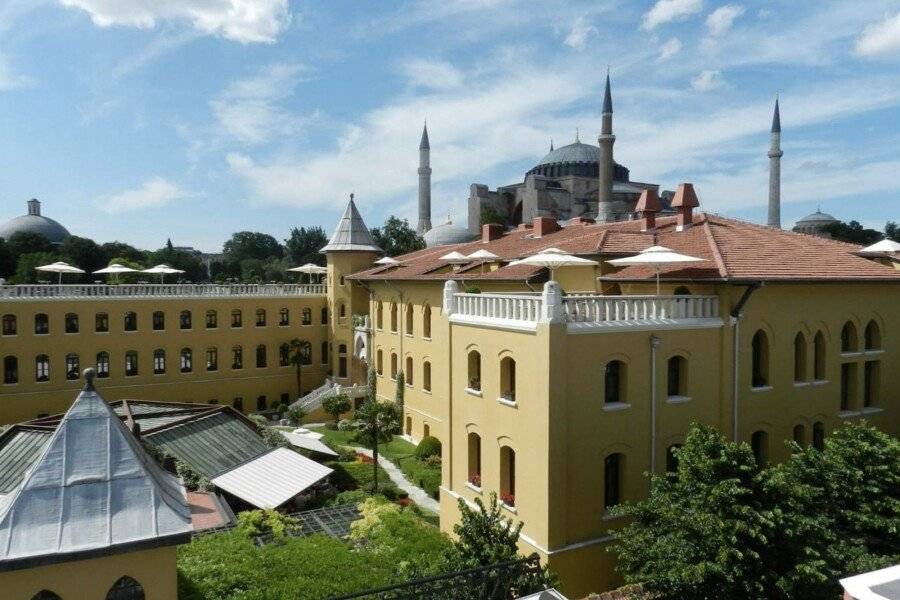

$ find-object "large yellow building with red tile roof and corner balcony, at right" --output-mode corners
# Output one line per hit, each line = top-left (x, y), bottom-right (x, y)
(328, 190), (900, 597)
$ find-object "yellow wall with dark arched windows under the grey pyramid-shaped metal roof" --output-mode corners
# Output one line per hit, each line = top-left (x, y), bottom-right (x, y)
(0, 546), (178, 600)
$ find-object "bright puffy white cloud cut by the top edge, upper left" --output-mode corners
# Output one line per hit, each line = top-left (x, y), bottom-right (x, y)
(59, 0), (291, 44)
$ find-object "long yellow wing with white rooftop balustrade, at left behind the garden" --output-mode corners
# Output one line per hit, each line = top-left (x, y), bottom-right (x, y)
(0, 284), (332, 424)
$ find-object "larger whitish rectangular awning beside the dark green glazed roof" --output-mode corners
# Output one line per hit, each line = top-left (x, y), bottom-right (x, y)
(212, 448), (332, 508)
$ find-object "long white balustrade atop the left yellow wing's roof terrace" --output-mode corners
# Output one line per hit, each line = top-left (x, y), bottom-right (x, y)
(0, 283), (326, 301)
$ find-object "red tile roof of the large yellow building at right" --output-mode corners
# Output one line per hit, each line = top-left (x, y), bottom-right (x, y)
(350, 213), (900, 282)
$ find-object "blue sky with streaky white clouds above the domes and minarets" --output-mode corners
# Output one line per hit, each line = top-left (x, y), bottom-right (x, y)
(0, 0), (900, 252)
